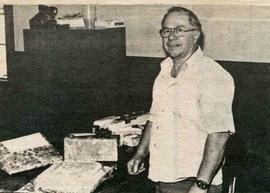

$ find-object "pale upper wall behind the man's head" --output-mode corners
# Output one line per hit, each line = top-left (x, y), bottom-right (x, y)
(14, 4), (270, 62)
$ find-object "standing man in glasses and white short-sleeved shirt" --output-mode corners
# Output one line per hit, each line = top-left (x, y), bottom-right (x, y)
(127, 7), (235, 193)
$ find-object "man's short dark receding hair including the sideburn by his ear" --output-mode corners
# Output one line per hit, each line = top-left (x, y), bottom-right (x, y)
(161, 7), (204, 48)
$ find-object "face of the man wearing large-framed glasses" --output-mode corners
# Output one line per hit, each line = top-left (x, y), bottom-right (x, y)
(162, 12), (199, 58)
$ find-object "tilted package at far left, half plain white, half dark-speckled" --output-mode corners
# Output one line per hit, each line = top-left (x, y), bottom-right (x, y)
(0, 133), (63, 174)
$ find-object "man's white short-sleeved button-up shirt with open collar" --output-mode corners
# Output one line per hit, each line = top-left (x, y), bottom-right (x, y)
(148, 48), (235, 184)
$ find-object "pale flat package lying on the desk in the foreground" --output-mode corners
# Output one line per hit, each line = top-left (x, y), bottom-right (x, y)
(34, 161), (112, 193)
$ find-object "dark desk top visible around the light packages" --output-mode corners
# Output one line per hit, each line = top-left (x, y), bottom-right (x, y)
(0, 147), (153, 193)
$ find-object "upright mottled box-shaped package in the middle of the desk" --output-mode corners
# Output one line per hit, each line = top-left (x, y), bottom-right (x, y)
(64, 135), (118, 162)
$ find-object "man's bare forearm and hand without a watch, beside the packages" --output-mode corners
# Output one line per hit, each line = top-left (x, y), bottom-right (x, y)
(127, 121), (152, 175)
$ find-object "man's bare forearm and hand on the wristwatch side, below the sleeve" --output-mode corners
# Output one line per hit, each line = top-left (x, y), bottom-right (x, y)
(189, 132), (230, 193)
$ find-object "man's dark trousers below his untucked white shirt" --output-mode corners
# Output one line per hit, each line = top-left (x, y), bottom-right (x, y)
(156, 178), (222, 193)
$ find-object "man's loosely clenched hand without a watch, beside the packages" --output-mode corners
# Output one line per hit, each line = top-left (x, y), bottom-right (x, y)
(127, 156), (145, 175)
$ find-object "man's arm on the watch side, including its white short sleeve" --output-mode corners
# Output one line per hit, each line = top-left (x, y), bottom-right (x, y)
(189, 71), (235, 193)
